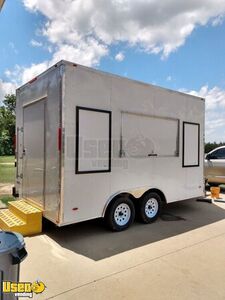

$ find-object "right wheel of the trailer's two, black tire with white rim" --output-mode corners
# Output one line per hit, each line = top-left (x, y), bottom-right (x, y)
(138, 192), (163, 224)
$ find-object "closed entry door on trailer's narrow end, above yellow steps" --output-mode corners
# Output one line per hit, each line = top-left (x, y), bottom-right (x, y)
(23, 100), (45, 207)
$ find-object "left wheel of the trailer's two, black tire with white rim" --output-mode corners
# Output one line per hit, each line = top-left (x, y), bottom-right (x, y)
(105, 197), (135, 231)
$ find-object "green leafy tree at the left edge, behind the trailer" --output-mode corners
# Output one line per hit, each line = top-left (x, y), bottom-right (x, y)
(0, 94), (16, 155)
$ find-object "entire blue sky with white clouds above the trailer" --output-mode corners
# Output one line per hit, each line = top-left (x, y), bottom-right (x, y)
(0, 0), (225, 141)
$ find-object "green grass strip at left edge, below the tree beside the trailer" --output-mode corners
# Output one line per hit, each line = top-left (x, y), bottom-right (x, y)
(0, 156), (15, 183)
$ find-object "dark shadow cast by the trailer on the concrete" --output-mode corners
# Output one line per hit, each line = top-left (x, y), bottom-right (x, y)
(43, 200), (225, 261)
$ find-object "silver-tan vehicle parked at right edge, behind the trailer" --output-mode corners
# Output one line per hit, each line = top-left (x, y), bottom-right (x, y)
(205, 146), (225, 186)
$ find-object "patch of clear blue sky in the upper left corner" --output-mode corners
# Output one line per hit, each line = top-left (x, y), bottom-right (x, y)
(0, 0), (50, 74)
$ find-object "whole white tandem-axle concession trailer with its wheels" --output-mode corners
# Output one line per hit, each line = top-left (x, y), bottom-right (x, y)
(15, 61), (205, 231)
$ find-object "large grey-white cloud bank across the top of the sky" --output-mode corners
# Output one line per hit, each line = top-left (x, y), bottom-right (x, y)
(23, 0), (225, 64)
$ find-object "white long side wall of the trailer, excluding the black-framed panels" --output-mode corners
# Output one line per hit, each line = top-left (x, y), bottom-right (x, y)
(62, 64), (204, 224)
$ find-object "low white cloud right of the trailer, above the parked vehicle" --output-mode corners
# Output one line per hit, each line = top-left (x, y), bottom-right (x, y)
(186, 85), (225, 142)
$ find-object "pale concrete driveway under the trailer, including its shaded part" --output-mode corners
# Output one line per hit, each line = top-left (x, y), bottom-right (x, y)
(21, 197), (225, 300)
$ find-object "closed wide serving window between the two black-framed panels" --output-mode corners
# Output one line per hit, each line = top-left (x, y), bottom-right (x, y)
(121, 112), (179, 157)
